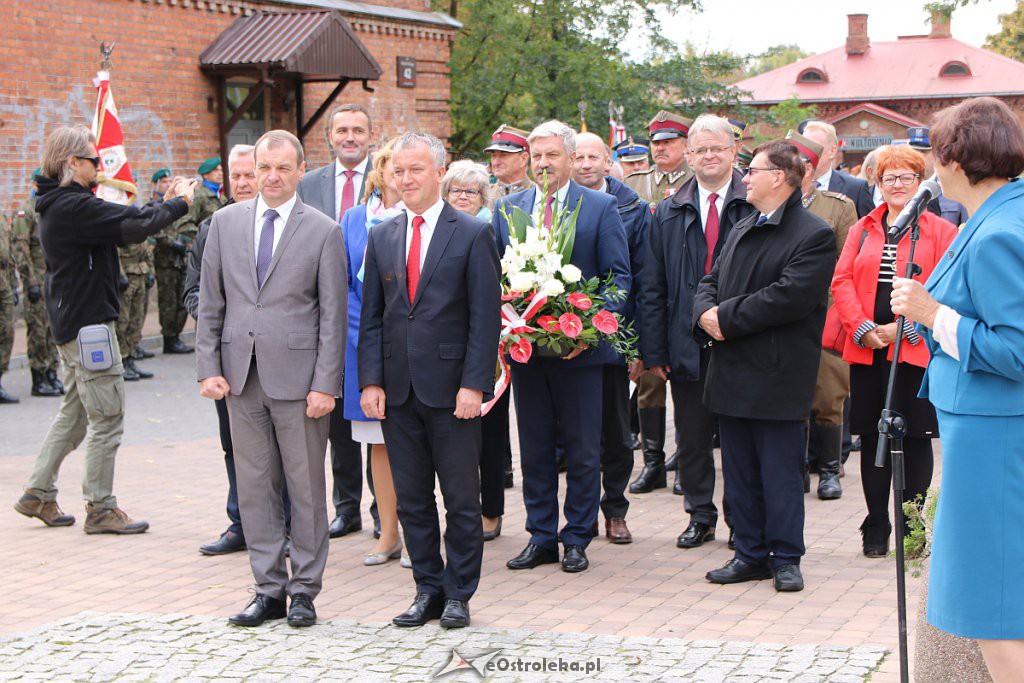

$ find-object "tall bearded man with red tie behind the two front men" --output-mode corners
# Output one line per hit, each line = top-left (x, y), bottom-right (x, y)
(298, 104), (380, 539)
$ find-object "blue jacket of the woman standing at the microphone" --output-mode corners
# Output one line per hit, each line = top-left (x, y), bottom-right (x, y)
(921, 181), (1024, 416)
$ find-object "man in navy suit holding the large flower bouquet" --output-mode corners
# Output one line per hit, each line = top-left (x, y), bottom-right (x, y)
(489, 121), (631, 571)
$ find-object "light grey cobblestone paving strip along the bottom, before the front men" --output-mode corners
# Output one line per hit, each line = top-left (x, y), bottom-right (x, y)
(0, 611), (889, 683)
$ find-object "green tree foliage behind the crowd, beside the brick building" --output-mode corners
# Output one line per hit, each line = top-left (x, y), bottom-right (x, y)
(434, 0), (770, 156)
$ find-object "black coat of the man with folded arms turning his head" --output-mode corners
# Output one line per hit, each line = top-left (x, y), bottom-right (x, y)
(693, 189), (836, 420)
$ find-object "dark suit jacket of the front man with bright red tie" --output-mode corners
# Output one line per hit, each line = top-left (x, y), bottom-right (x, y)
(357, 202), (501, 408)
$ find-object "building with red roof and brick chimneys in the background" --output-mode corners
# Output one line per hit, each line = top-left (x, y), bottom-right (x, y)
(735, 12), (1024, 164)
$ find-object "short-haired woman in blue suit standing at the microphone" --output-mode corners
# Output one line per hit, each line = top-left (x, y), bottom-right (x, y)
(892, 97), (1024, 682)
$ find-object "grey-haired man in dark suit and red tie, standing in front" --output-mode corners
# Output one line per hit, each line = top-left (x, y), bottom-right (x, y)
(358, 133), (501, 629)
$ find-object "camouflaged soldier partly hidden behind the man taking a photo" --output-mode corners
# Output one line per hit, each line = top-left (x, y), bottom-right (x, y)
(10, 169), (65, 396)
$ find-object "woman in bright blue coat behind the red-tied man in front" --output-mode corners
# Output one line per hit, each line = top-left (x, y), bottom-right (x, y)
(341, 137), (411, 566)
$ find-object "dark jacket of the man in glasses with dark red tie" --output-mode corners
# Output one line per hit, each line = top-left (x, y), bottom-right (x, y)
(640, 171), (757, 380)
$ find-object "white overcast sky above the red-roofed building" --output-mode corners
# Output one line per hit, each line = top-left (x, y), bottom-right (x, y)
(663, 0), (1017, 54)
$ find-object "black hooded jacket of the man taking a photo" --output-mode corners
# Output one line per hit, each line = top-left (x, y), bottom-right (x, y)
(36, 176), (188, 344)
